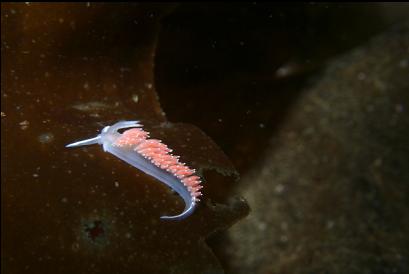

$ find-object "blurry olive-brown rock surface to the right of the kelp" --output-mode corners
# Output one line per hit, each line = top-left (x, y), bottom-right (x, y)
(228, 23), (409, 274)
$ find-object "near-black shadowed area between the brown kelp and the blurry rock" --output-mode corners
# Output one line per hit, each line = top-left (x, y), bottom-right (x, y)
(155, 3), (404, 173)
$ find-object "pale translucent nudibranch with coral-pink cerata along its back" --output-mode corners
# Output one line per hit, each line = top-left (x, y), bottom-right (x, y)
(66, 121), (202, 220)
